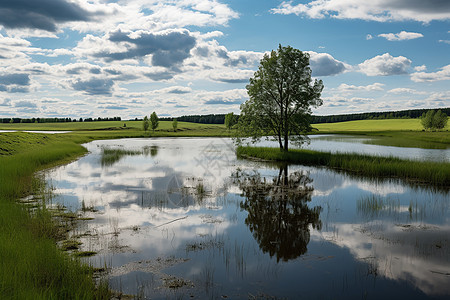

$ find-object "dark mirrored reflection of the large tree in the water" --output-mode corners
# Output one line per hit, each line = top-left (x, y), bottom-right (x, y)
(238, 165), (322, 261)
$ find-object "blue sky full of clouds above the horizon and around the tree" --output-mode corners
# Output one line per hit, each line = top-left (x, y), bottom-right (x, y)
(0, 0), (450, 119)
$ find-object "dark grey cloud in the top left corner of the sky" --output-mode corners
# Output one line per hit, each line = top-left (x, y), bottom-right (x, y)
(0, 0), (96, 32)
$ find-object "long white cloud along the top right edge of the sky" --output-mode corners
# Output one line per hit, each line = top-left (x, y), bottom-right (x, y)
(271, 0), (450, 23)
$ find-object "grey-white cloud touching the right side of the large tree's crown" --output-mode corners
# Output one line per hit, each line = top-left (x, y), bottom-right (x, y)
(306, 51), (351, 76)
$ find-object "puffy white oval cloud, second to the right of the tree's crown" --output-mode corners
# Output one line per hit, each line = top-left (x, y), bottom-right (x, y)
(358, 53), (411, 76)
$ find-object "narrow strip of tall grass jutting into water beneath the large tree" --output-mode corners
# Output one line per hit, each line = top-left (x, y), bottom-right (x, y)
(237, 147), (450, 187)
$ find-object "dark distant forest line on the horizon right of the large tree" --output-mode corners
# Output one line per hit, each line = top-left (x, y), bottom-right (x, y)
(311, 107), (450, 124)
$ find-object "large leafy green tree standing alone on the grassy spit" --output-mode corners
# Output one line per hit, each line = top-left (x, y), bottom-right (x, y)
(237, 45), (323, 151)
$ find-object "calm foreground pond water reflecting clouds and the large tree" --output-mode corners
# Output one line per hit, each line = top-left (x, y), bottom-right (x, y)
(46, 138), (450, 299)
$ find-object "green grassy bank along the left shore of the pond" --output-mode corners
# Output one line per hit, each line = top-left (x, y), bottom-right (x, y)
(0, 133), (109, 299)
